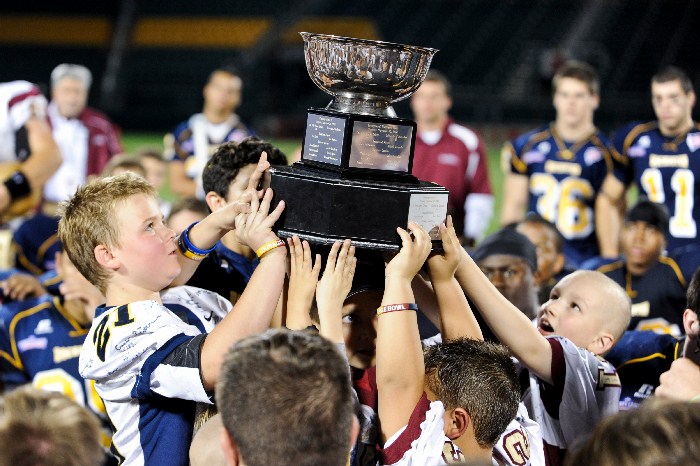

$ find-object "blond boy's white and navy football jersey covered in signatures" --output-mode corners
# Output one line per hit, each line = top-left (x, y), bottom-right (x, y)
(80, 287), (231, 466)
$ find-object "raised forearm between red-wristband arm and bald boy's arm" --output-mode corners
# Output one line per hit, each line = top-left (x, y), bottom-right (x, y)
(428, 216), (484, 340)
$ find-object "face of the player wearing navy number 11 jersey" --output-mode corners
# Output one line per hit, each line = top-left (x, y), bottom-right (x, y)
(651, 80), (695, 135)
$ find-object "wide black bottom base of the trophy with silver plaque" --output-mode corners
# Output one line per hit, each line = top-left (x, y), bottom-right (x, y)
(270, 164), (448, 251)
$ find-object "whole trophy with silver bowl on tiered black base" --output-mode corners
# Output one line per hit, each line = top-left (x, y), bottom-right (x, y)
(270, 32), (448, 250)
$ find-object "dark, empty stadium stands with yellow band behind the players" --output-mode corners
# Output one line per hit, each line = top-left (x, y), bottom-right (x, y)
(0, 0), (700, 131)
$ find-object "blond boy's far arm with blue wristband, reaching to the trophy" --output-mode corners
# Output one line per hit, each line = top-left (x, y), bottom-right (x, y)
(171, 152), (274, 286)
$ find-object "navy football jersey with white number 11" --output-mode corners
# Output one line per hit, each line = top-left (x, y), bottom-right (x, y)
(612, 121), (700, 251)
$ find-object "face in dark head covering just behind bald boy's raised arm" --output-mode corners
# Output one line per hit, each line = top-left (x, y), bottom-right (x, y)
(478, 254), (537, 319)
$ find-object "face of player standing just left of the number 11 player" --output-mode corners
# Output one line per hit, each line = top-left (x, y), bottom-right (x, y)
(553, 78), (599, 126)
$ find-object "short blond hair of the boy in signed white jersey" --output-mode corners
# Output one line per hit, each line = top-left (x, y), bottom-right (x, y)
(58, 173), (157, 294)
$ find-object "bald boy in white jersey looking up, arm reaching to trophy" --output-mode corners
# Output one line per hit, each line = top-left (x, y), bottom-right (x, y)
(456, 244), (630, 465)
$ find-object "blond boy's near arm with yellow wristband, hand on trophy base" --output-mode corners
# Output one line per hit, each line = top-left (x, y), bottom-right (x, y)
(201, 189), (287, 390)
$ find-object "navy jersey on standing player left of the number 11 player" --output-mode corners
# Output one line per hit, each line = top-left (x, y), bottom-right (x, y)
(502, 124), (624, 264)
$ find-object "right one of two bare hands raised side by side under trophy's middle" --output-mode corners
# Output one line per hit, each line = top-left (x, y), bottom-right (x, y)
(316, 239), (357, 343)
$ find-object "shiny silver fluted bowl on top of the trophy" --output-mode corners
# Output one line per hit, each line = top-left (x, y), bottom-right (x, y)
(300, 32), (437, 117)
